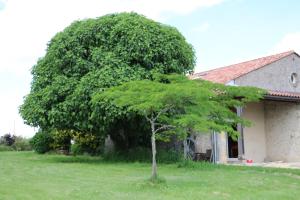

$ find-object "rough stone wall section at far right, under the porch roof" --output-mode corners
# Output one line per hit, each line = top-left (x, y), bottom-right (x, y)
(265, 101), (300, 162)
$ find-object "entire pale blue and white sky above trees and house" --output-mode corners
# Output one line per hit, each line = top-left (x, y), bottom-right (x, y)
(0, 0), (300, 137)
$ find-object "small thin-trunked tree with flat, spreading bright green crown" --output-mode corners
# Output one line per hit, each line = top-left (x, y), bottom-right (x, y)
(93, 75), (263, 179)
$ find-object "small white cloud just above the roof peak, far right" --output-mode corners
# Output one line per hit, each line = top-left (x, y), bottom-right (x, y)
(271, 32), (300, 53)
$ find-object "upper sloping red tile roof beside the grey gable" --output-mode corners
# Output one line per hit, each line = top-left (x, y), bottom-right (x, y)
(190, 51), (298, 84)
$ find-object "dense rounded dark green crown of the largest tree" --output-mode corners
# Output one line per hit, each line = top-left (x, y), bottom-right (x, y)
(20, 13), (195, 145)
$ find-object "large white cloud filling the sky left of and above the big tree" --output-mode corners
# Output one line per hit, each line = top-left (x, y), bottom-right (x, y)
(0, 0), (224, 136)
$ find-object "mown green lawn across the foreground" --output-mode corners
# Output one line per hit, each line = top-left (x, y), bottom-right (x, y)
(0, 152), (300, 200)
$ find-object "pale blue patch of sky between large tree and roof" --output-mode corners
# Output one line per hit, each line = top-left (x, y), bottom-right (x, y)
(168, 0), (300, 71)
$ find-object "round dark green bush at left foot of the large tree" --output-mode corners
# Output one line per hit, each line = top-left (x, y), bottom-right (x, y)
(30, 131), (53, 154)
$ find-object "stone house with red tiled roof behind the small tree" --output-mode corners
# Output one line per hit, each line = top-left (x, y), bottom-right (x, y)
(191, 51), (300, 163)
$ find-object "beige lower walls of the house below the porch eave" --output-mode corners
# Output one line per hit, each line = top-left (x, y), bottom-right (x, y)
(196, 101), (300, 163)
